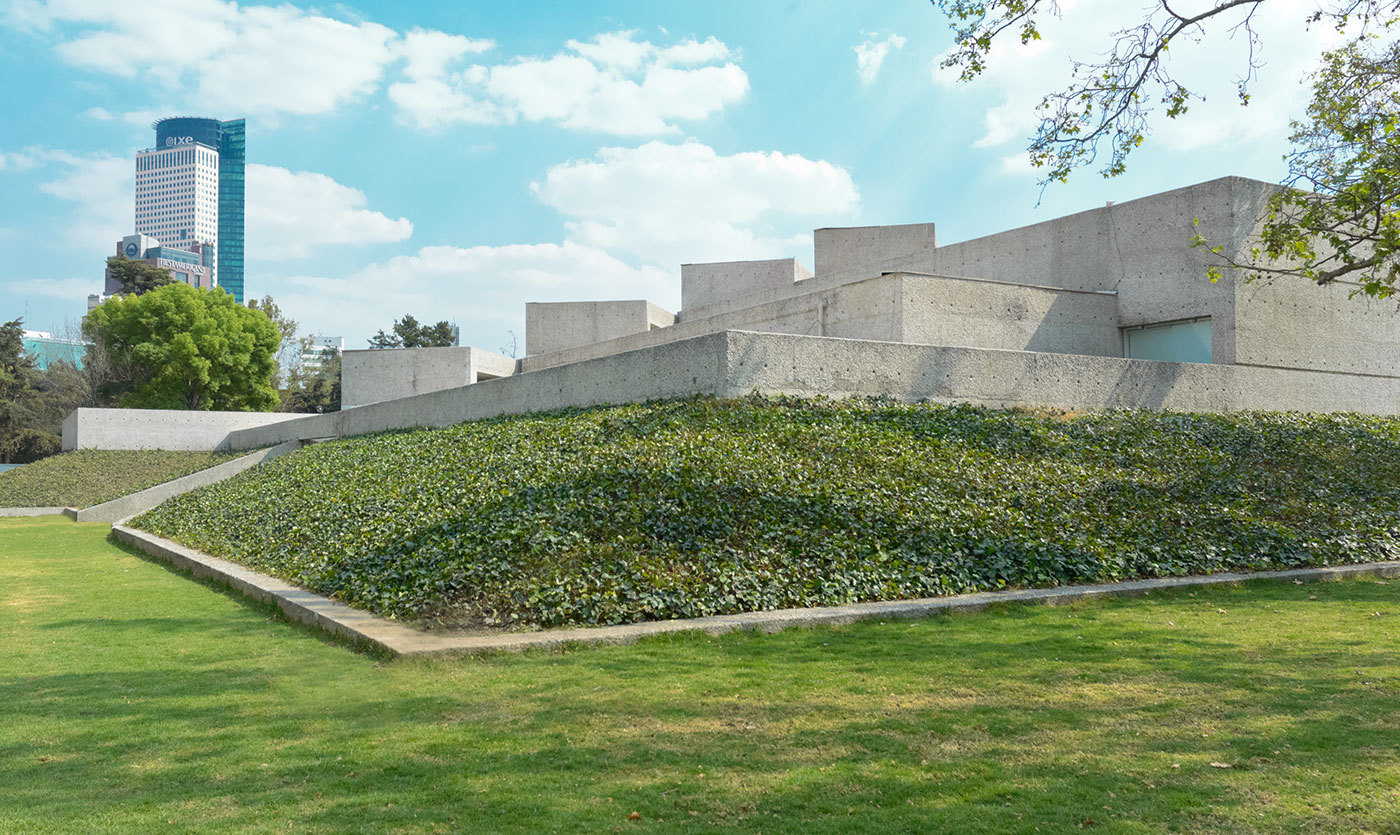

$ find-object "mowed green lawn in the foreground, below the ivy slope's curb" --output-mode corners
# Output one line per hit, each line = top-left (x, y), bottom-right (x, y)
(0, 518), (1400, 832)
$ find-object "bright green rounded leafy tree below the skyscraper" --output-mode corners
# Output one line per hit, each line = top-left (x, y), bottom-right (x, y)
(88, 283), (279, 412)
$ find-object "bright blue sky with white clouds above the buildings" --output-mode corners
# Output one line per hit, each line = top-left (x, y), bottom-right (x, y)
(0, 0), (1336, 350)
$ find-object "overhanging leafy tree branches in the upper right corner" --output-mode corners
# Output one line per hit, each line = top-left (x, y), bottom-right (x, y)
(931, 0), (1400, 298)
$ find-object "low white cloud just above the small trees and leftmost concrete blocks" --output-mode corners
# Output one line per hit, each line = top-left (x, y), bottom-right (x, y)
(273, 241), (675, 350)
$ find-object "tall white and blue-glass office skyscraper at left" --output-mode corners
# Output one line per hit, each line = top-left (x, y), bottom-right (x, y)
(136, 116), (245, 304)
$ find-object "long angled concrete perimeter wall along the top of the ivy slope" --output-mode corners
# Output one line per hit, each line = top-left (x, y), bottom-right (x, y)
(212, 331), (1400, 448)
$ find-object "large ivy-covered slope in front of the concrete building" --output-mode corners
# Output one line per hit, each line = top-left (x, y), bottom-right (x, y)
(134, 398), (1400, 626)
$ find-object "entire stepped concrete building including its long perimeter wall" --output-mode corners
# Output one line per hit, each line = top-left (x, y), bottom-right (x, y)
(64, 177), (1400, 450)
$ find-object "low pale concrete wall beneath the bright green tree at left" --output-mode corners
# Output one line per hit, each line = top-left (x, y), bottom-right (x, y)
(63, 409), (302, 450)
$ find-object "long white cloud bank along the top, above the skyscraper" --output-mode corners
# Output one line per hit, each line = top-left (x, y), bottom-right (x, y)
(16, 0), (749, 136)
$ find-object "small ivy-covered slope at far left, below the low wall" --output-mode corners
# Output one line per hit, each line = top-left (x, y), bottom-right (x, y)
(0, 450), (244, 507)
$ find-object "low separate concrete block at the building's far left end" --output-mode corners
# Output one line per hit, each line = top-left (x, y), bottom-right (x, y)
(340, 347), (515, 409)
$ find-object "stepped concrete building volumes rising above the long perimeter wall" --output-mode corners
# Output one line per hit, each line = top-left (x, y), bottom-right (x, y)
(344, 177), (1400, 406)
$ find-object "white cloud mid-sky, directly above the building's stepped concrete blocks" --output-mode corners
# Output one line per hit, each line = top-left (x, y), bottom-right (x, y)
(532, 142), (860, 269)
